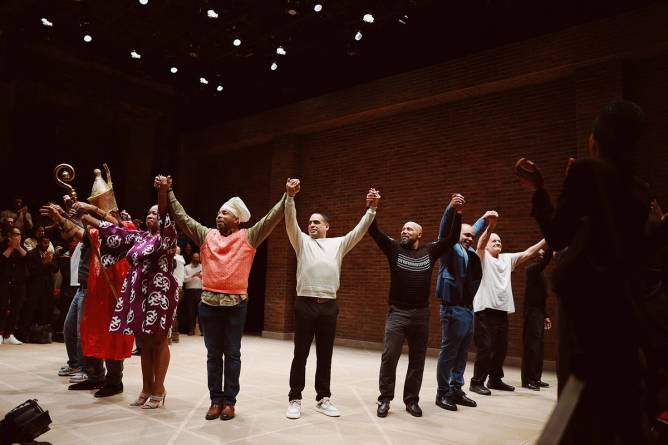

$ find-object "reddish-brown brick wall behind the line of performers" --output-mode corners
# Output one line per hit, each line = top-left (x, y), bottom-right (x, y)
(177, 4), (668, 359)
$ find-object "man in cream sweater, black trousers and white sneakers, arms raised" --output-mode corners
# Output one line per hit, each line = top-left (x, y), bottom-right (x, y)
(285, 178), (380, 419)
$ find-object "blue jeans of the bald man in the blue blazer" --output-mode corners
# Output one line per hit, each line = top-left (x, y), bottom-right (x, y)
(436, 306), (473, 397)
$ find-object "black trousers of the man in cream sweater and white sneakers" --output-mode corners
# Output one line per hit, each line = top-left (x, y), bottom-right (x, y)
(288, 297), (339, 400)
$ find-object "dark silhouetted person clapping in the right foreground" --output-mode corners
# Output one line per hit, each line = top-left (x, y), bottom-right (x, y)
(516, 100), (649, 444)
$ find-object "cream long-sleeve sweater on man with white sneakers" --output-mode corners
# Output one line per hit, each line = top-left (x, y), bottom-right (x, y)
(285, 197), (376, 298)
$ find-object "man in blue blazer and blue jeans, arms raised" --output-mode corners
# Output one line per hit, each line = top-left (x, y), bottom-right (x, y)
(436, 194), (498, 411)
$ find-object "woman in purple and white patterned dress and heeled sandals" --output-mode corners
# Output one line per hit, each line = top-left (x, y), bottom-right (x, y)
(99, 176), (178, 409)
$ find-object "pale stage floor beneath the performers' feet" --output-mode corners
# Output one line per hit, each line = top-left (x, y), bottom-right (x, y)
(0, 336), (556, 445)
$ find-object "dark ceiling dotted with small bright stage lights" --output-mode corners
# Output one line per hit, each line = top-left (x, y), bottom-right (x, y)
(0, 0), (654, 126)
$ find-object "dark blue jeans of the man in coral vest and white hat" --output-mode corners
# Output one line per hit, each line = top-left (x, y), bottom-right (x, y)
(199, 300), (247, 406)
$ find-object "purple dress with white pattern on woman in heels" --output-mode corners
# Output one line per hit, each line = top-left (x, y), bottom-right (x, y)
(99, 215), (178, 335)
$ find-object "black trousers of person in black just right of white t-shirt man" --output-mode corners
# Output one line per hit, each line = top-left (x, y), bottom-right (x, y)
(522, 306), (545, 385)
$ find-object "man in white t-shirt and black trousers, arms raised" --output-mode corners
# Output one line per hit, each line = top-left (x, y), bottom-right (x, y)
(469, 213), (546, 396)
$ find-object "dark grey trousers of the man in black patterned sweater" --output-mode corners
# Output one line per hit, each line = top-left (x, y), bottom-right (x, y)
(378, 305), (429, 404)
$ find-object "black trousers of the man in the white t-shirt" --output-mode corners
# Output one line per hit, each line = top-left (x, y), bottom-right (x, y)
(471, 309), (508, 385)
